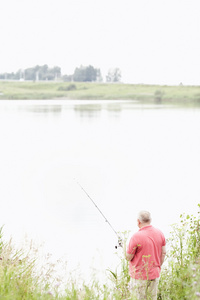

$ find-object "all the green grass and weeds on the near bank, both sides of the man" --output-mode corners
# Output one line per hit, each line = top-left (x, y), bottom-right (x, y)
(0, 205), (200, 300)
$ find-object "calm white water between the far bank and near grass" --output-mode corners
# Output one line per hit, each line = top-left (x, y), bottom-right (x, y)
(0, 100), (200, 284)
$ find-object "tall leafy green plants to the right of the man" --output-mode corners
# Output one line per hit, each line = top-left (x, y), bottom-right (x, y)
(158, 205), (200, 300)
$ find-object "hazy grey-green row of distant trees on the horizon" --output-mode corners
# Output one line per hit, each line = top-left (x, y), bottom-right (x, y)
(0, 65), (121, 82)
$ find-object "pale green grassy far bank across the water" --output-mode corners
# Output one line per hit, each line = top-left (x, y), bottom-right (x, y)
(0, 81), (200, 103)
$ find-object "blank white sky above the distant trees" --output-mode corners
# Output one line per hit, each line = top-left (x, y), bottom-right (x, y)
(0, 0), (200, 85)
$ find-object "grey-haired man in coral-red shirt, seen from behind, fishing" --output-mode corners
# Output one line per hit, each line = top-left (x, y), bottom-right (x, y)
(126, 211), (166, 300)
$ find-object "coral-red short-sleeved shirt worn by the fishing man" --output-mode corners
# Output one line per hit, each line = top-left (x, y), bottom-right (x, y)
(127, 225), (166, 280)
